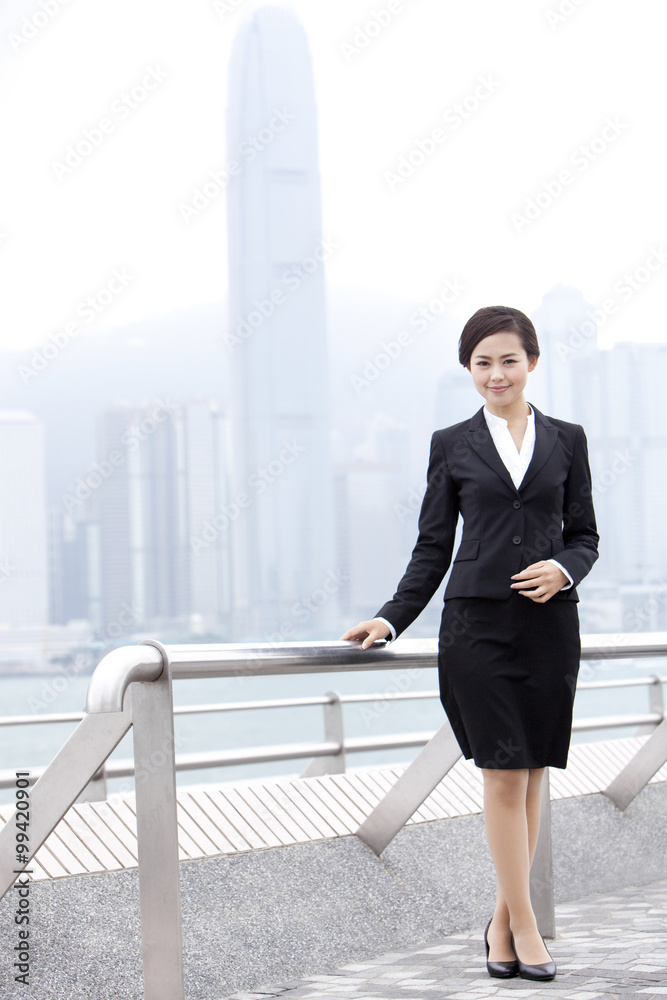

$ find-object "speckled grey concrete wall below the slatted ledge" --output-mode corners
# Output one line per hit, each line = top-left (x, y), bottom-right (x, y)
(0, 784), (667, 1000)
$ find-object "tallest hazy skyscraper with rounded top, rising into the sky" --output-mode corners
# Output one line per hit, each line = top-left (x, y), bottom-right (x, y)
(225, 6), (338, 640)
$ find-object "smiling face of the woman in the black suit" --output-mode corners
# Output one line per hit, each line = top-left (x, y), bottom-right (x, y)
(468, 331), (537, 408)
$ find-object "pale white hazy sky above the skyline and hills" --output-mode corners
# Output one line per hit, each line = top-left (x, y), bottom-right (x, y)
(0, 0), (667, 347)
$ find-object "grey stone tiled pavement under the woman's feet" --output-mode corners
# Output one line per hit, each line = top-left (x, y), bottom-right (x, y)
(226, 881), (667, 1000)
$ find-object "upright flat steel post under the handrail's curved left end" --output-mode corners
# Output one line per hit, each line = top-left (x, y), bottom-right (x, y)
(132, 640), (185, 1000)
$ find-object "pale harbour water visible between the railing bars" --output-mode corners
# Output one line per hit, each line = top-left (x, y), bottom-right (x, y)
(0, 658), (667, 803)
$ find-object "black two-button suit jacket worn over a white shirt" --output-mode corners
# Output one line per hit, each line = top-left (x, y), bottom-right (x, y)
(376, 403), (599, 635)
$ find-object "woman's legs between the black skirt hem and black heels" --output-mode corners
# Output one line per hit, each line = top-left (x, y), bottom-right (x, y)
(483, 768), (550, 965)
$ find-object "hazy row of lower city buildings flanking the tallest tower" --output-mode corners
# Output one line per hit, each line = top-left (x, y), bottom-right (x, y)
(0, 289), (667, 642)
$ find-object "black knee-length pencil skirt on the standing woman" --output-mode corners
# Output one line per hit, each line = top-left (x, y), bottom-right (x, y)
(438, 591), (581, 769)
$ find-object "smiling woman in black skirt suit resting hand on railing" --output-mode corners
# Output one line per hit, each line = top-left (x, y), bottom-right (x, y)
(341, 306), (598, 980)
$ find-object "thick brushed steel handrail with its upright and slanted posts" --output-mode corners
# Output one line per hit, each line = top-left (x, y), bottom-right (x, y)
(0, 633), (667, 1000)
